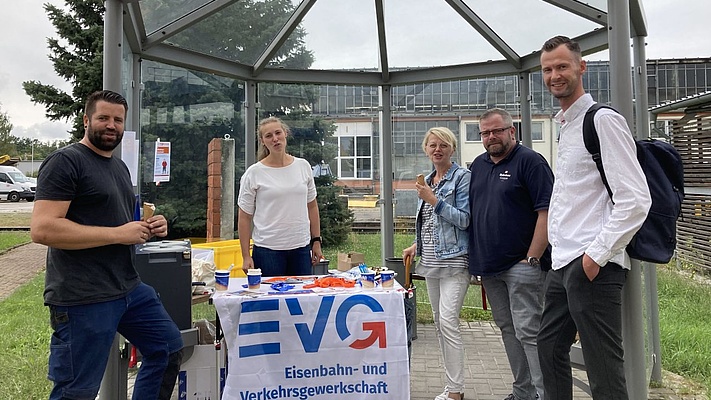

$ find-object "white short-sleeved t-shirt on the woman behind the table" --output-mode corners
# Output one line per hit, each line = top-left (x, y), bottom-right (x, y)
(237, 157), (316, 250)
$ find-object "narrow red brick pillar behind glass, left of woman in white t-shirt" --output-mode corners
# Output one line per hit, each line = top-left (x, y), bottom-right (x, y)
(207, 139), (222, 242)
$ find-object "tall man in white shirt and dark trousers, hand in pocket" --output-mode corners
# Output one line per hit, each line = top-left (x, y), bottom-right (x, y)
(538, 36), (651, 400)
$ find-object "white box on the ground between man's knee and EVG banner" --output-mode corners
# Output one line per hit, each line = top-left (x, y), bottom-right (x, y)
(177, 342), (226, 400)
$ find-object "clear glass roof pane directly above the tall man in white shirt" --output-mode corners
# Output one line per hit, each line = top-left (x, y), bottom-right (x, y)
(464, 0), (606, 56)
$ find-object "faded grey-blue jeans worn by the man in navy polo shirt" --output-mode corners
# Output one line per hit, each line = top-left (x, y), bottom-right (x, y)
(481, 263), (545, 400)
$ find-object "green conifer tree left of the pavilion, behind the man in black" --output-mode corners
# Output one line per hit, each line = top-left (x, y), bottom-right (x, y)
(22, 0), (104, 140)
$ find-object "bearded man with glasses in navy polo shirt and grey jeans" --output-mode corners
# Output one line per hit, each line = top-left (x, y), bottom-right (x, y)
(469, 108), (553, 400)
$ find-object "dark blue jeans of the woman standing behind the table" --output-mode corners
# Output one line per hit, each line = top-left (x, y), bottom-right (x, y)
(252, 246), (311, 276)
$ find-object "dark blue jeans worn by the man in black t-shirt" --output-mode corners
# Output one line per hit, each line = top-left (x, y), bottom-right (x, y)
(47, 283), (183, 400)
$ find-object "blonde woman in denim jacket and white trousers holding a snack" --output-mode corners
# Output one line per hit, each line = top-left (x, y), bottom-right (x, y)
(402, 128), (471, 400)
